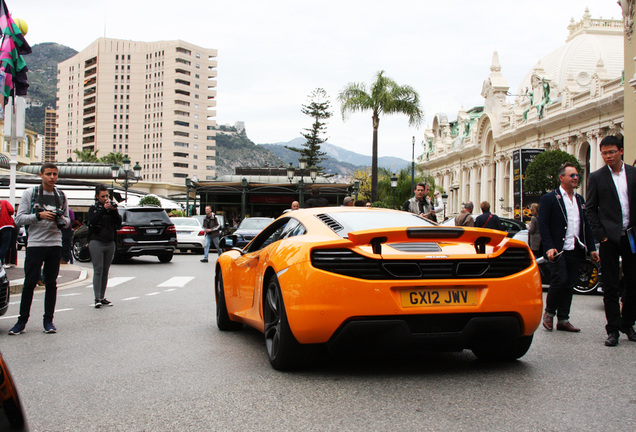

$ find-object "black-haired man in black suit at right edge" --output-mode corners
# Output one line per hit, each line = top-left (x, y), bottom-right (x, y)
(586, 136), (636, 346)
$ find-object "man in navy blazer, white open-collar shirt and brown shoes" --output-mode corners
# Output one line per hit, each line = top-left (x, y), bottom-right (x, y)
(539, 162), (599, 332)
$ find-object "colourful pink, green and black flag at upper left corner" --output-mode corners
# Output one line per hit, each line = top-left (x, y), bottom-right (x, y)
(0, 0), (31, 100)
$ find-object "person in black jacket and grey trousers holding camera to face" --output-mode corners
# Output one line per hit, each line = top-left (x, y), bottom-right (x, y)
(88, 184), (121, 309)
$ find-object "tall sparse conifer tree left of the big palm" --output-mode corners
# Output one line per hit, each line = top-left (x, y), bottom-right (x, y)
(285, 88), (333, 175)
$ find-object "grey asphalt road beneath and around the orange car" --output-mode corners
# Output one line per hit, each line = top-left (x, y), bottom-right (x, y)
(0, 255), (636, 432)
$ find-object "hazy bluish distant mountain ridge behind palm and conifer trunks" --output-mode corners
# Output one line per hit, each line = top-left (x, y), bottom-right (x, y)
(259, 137), (411, 175)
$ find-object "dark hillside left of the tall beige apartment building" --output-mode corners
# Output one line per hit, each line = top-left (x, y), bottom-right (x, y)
(24, 42), (77, 134)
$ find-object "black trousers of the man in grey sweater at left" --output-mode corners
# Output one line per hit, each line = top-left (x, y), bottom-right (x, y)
(18, 246), (62, 324)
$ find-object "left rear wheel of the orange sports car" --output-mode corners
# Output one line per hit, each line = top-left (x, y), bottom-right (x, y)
(263, 275), (303, 371)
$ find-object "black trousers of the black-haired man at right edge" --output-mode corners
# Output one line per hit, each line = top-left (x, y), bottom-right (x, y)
(600, 236), (636, 334)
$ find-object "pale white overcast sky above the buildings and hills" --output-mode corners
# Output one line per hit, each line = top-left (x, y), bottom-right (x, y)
(12, 0), (621, 160)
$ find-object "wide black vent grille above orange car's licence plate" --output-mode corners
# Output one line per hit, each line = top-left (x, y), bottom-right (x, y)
(311, 248), (532, 280)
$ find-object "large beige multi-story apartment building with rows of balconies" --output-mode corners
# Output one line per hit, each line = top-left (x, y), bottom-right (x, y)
(57, 38), (217, 184)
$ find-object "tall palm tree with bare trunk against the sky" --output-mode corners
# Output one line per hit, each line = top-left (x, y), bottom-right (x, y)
(338, 71), (424, 201)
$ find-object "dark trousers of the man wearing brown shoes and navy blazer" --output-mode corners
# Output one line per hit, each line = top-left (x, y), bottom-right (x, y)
(545, 249), (584, 321)
